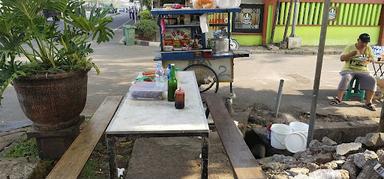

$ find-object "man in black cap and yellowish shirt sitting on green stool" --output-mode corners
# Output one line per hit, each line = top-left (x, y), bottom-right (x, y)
(331, 33), (376, 111)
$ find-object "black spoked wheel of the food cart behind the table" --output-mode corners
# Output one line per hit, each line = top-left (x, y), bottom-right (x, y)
(184, 64), (219, 93)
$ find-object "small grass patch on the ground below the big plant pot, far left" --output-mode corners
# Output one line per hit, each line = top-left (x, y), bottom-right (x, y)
(4, 138), (39, 158)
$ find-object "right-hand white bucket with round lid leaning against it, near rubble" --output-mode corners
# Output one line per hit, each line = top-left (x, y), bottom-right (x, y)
(284, 122), (309, 153)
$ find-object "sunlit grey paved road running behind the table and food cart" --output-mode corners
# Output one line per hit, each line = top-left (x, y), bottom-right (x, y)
(0, 42), (380, 131)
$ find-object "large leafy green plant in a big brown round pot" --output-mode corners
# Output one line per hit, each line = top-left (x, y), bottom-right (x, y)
(0, 0), (113, 158)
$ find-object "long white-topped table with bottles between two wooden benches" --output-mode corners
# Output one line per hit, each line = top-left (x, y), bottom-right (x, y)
(106, 71), (209, 178)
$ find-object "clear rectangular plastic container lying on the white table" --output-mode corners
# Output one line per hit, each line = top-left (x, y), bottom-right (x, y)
(129, 82), (166, 100)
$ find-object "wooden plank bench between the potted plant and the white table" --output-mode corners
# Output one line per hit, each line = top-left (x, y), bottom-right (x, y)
(47, 96), (122, 179)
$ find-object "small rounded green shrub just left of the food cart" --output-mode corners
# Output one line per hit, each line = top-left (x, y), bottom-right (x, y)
(136, 19), (158, 40)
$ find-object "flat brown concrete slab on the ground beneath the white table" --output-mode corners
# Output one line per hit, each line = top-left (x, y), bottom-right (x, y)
(126, 132), (233, 179)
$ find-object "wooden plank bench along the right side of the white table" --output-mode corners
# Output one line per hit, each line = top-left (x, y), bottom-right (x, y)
(203, 94), (266, 179)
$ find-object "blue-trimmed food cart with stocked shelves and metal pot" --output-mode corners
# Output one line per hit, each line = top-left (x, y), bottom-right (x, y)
(151, 8), (249, 94)
